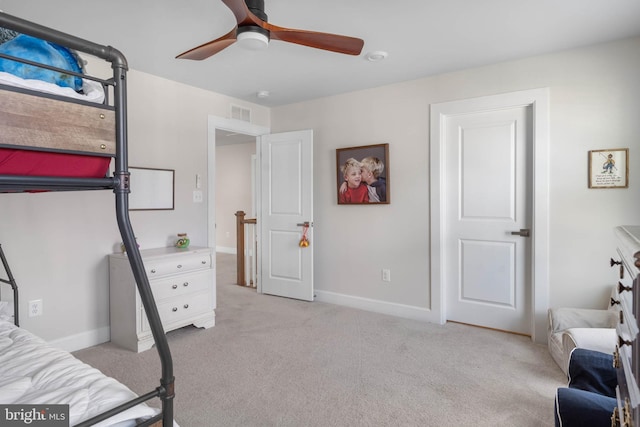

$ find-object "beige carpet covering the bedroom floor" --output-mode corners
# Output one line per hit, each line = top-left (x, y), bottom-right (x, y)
(75, 254), (566, 427)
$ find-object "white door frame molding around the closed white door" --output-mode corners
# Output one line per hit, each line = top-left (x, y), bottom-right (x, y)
(429, 88), (549, 343)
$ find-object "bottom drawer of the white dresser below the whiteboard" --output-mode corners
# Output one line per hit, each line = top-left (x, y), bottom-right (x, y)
(142, 291), (212, 332)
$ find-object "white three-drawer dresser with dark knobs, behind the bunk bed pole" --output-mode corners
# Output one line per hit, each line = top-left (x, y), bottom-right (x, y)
(109, 247), (216, 352)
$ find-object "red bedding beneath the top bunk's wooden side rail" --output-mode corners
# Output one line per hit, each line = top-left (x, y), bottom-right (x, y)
(0, 148), (111, 178)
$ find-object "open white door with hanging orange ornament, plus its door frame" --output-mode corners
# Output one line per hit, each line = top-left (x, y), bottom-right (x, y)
(207, 116), (313, 301)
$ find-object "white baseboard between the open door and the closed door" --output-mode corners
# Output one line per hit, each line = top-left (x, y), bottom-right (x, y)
(315, 289), (439, 323)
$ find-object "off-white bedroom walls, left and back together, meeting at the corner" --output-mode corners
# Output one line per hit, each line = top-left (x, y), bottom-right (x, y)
(0, 34), (640, 349)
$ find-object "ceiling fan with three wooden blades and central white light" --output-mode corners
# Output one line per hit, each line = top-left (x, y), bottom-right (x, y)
(176, 0), (364, 60)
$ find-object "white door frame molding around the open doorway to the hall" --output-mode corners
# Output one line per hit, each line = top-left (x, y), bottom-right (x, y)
(207, 115), (271, 251)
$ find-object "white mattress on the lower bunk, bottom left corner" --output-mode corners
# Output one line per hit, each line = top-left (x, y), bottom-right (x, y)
(0, 321), (165, 426)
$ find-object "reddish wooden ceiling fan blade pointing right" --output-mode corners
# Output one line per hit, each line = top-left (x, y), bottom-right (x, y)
(263, 22), (364, 55)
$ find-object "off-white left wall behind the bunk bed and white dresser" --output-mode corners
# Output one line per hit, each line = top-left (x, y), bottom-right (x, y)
(0, 71), (270, 349)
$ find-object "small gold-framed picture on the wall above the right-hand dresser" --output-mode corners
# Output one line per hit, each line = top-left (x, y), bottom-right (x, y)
(589, 148), (629, 188)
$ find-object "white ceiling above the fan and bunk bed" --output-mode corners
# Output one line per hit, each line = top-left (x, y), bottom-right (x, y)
(0, 0), (640, 106)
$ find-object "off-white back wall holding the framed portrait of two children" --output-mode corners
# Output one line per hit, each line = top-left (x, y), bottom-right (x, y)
(271, 38), (640, 316)
